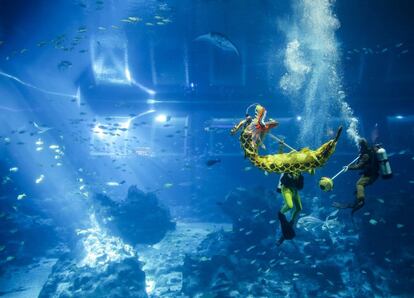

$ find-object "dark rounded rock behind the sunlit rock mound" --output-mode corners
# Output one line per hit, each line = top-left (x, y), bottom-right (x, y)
(93, 186), (175, 245)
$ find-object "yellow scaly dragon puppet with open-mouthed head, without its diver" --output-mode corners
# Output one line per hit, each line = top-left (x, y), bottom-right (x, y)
(231, 106), (342, 174)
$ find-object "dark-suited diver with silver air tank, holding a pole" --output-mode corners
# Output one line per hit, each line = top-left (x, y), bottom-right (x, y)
(332, 138), (392, 215)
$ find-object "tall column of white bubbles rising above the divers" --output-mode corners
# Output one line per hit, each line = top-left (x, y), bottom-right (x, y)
(279, 0), (359, 146)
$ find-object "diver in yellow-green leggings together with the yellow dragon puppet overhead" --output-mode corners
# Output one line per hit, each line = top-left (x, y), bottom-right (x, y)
(231, 104), (342, 245)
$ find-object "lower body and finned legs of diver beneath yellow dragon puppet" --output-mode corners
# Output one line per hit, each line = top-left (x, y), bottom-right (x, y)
(277, 173), (303, 246)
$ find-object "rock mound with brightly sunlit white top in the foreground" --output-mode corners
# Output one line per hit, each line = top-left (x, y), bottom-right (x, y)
(39, 215), (147, 298)
